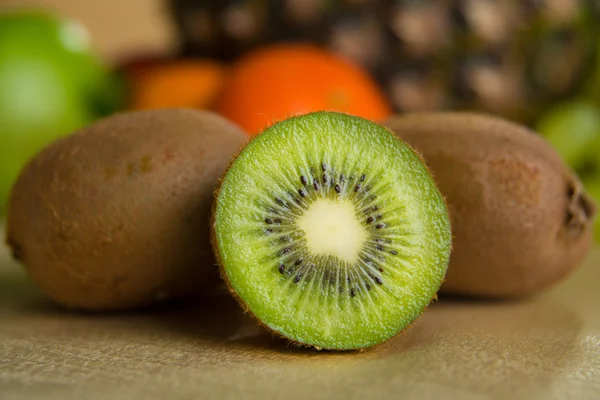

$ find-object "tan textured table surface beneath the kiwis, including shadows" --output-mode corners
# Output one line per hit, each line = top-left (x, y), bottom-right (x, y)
(0, 239), (600, 400)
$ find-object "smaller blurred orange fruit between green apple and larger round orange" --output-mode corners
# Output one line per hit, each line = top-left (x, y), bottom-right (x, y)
(129, 60), (227, 110)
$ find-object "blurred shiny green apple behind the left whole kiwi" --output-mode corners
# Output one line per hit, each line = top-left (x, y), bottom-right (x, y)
(0, 12), (121, 216)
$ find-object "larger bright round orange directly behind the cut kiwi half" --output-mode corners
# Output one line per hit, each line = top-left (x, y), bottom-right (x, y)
(215, 44), (392, 134)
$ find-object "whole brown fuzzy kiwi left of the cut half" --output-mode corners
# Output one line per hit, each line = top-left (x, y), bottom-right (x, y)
(7, 109), (247, 310)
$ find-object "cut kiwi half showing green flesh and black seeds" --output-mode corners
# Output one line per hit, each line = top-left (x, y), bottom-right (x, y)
(212, 112), (451, 350)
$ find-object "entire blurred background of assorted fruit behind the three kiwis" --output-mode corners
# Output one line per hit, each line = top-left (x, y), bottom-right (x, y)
(0, 0), (600, 237)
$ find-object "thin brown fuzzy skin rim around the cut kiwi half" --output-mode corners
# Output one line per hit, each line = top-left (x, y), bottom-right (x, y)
(210, 115), (452, 353)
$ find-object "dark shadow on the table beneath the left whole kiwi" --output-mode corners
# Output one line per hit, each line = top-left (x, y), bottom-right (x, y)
(0, 268), (316, 355)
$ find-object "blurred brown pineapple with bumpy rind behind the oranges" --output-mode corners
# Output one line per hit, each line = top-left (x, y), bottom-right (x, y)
(171, 0), (600, 123)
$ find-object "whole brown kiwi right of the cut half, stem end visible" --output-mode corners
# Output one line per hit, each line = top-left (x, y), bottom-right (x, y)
(385, 112), (596, 298)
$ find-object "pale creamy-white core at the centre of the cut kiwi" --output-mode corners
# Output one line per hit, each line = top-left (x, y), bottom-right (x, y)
(296, 199), (367, 263)
